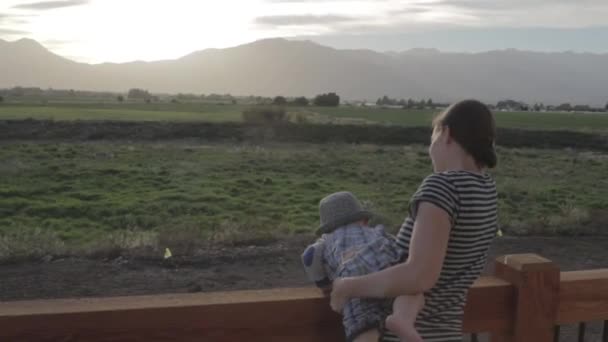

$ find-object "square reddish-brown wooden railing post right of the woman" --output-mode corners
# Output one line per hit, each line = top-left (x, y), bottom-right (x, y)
(492, 254), (560, 342)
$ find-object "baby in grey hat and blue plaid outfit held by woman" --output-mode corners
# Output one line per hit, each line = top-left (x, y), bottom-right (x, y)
(302, 192), (424, 342)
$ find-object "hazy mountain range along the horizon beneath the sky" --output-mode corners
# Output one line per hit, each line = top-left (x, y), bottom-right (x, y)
(0, 38), (608, 106)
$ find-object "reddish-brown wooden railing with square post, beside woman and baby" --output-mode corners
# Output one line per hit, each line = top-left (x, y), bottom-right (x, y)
(0, 254), (608, 342)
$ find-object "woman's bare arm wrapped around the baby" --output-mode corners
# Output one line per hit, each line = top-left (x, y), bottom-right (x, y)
(331, 202), (451, 311)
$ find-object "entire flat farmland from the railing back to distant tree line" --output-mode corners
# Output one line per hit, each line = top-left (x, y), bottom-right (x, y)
(0, 97), (608, 322)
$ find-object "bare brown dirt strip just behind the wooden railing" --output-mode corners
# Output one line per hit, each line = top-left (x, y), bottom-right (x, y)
(0, 237), (608, 342)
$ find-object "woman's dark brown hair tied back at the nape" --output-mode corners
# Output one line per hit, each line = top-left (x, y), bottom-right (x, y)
(433, 100), (497, 168)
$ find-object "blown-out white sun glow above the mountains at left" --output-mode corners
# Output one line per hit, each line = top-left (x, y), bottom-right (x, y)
(5, 0), (263, 63)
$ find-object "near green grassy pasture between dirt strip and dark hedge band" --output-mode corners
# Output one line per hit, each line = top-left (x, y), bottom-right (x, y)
(0, 141), (608, 256)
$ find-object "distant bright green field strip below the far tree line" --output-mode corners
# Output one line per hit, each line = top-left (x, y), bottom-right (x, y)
(0, 103), (608, 132)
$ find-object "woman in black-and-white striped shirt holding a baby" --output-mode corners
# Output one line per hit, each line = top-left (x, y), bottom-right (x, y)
(331, 100), (498, 342)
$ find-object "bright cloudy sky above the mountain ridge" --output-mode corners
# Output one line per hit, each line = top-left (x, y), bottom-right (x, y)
(0, 0), (608, 63)
